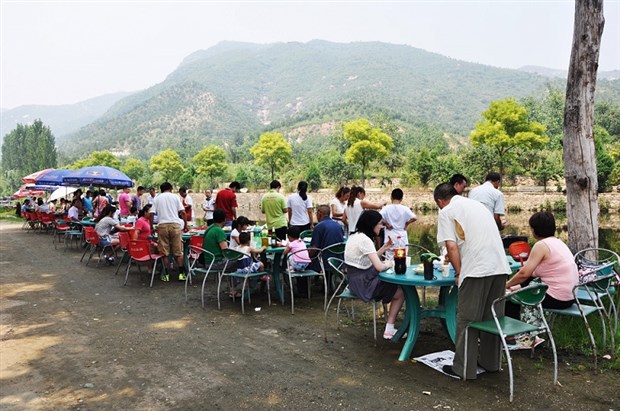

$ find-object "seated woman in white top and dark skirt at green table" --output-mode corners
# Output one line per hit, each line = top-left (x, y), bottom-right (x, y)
(344, 210), (404, 340)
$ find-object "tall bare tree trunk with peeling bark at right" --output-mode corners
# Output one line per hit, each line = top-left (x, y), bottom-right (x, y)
(564, 0), (605, 253)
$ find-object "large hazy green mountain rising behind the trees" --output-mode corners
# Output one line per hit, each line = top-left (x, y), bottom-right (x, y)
(59, 40), (620, 158)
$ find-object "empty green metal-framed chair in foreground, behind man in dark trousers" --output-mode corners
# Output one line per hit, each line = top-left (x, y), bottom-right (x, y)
(463, 283), (558, 402)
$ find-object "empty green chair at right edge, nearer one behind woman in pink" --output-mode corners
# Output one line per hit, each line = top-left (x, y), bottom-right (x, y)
(544, 274), (615, 372)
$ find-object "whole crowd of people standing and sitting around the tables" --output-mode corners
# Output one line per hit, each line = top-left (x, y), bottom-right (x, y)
(17, 173), (578, 379)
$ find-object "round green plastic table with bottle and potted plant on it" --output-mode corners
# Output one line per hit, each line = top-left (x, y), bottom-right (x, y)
(379, 265), (458, 361)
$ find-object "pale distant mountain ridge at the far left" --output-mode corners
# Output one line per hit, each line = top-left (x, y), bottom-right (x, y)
(0, 92), (131, 144)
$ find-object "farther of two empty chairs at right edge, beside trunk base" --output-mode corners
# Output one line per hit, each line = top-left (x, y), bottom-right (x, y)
(575, 248), (620, 333)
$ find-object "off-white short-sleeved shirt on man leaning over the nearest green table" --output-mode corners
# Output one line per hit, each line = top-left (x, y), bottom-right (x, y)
(437, 195), (510, 285)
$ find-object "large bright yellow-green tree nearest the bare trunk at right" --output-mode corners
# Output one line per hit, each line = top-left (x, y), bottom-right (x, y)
(469, 98), (549, 179)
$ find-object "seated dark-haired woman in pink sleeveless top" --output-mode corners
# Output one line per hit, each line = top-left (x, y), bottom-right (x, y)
(506, 211), (579, 318)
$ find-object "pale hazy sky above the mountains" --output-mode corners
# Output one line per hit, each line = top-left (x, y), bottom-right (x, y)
(0, 0), (620, 109)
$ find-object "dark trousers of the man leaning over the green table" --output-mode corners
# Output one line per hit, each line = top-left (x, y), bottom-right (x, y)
(452, 274), (508, 379)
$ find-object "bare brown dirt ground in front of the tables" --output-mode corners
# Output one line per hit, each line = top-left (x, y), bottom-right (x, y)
(0, 222), (620, 411)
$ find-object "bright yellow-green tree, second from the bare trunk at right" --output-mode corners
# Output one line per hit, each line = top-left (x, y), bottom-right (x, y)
(344, 118), (394, 186)
